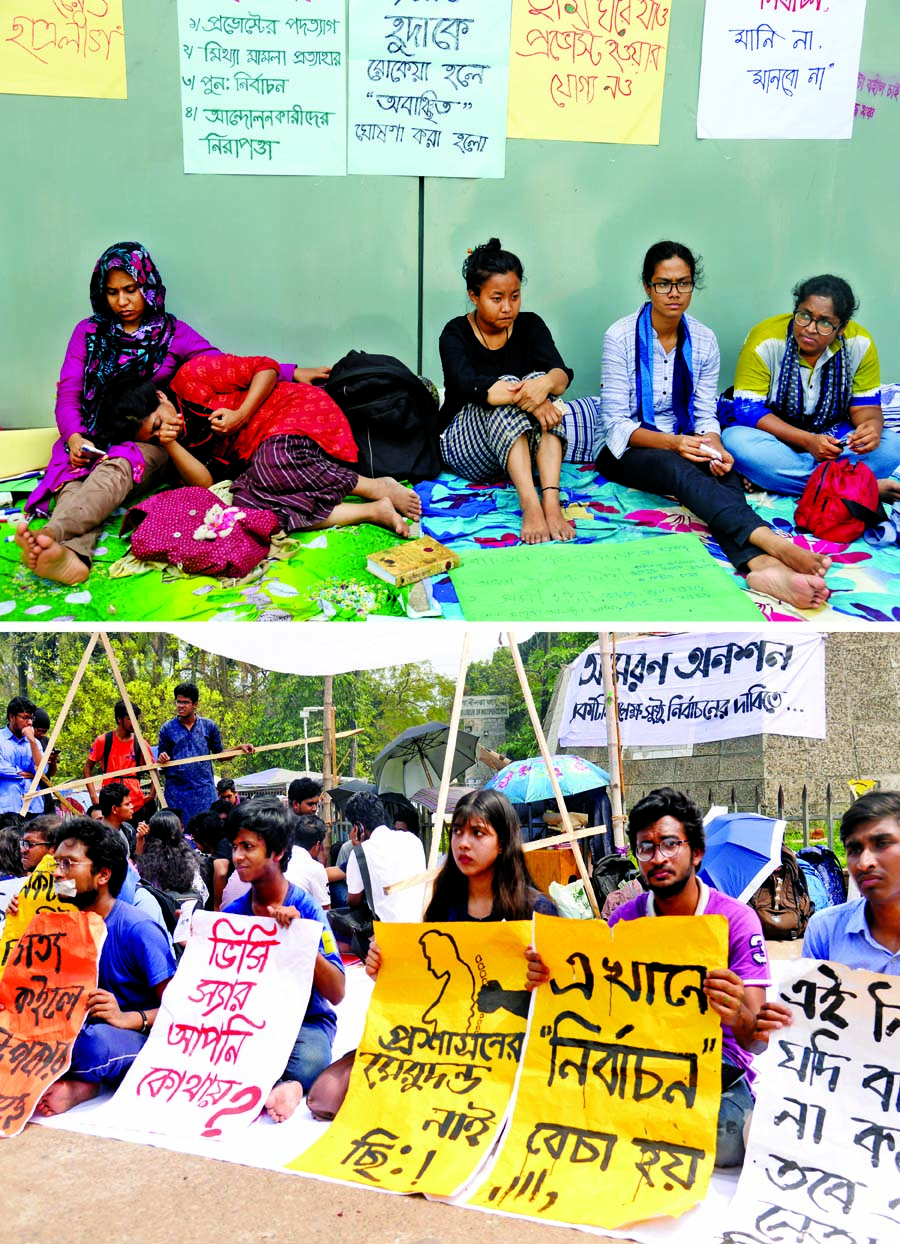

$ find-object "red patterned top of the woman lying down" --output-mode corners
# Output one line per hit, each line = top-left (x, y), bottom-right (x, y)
(172, 355), (359, 463)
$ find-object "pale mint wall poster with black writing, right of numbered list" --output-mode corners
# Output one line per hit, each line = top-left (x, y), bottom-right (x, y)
(347, 0), (512, 177)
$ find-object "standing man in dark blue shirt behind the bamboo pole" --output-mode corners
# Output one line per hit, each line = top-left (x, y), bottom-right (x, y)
(157, 683), (254, 825)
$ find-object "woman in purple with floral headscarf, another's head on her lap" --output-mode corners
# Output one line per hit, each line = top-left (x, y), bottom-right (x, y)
(16, 241), (306, 583)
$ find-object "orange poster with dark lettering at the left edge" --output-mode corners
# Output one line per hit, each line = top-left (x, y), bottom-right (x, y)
(0, 906), (106, 1136)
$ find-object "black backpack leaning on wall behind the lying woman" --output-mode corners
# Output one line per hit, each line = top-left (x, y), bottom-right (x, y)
(324, 350), (443, 484)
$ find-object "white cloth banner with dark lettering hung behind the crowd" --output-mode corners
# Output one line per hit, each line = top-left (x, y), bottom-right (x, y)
(559, 629), (825, 748)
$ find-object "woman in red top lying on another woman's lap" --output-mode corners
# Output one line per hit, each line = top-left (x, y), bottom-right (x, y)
(98, 355), (422, 536)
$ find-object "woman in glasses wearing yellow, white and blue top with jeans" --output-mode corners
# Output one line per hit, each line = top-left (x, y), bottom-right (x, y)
(722, 276), (900, 501)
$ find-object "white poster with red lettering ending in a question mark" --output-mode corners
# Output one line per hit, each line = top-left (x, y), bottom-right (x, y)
(106, 912), (322, 1138)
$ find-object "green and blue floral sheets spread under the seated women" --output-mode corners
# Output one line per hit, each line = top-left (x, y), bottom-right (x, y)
(0, 464), (900, 626)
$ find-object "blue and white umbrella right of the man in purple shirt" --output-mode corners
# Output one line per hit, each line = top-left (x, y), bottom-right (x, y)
(700, 807), (784, 903)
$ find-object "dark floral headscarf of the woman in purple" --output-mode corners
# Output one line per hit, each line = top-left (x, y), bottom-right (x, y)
(82, 241), (176, 435)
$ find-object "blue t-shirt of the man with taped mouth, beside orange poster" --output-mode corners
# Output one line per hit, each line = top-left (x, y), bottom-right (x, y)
(98, 899), (176, 1010)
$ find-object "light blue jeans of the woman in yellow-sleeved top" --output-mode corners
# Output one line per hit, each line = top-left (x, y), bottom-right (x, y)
(722, 423), (900, 496)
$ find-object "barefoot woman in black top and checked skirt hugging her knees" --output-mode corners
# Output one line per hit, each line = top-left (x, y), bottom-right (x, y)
(441, 238), (575, 544)
